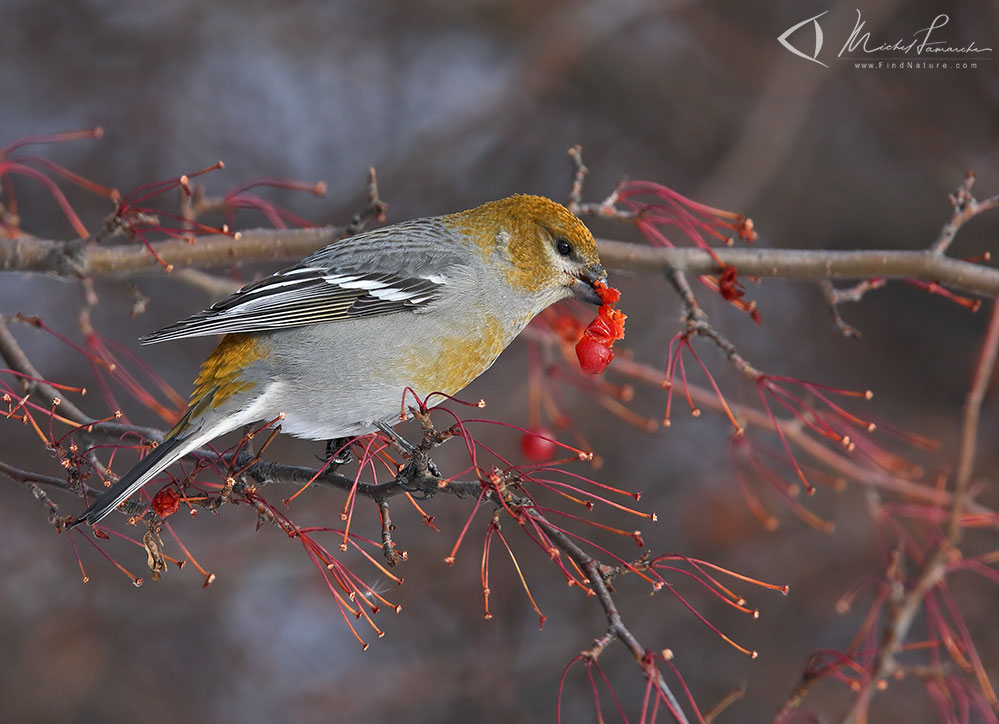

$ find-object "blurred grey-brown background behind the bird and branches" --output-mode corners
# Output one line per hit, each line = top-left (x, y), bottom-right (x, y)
(0, 0), (999, 723)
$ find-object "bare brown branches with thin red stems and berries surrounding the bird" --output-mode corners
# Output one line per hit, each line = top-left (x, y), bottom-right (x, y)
(0, 131), (999, 724)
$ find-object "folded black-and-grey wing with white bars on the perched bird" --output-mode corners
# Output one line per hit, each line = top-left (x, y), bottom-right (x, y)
(140, 225), (455, 344)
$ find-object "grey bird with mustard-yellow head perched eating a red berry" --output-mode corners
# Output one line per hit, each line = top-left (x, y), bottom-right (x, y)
(71, 194), (606, 527)
